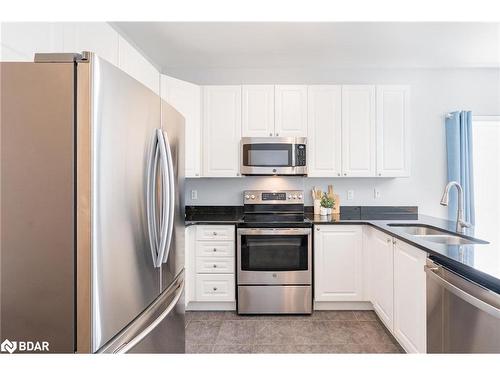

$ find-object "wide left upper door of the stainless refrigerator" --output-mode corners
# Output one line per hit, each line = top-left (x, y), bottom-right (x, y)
(91, 56), (161, 351)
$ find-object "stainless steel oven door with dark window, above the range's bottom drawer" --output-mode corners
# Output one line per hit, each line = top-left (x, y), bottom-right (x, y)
(237, 228), (312, 285)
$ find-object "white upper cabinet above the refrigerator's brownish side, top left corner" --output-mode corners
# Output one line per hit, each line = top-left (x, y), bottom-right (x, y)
(0, 22), (63, 61)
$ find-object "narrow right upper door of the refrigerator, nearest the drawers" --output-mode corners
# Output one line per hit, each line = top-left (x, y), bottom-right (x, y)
(161, 101), (185, 290)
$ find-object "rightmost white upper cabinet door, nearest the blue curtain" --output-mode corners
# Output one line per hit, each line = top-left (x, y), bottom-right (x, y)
(377, 86), (410, 177)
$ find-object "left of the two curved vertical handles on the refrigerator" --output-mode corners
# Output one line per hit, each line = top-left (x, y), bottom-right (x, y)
(146, 132), (159, 267)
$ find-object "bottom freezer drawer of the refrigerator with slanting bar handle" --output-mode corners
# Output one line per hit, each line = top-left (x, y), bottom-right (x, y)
(99, 272), (185, 353)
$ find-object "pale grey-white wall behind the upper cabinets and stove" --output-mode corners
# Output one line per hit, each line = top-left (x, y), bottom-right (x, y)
(183, 68), (500, 217)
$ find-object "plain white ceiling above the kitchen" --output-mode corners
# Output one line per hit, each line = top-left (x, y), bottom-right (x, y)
(113, 22), (500, 71)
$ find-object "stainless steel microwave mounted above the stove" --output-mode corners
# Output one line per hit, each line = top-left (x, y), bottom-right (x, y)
(240, 137), (307, 176)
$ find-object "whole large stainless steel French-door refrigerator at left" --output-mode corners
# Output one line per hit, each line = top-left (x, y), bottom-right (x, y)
(0, 53), (184, 353)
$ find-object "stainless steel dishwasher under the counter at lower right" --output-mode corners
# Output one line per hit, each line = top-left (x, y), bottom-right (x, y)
(425, 260), (500, 353)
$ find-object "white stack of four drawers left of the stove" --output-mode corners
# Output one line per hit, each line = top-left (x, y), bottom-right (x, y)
(188, 225), (236, 303)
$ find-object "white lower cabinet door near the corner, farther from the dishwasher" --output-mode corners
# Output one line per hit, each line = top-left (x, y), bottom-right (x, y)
(366, 229), (394, 332)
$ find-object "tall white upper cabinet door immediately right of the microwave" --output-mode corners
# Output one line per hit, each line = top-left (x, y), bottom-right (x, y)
(307, 85), (342, 177)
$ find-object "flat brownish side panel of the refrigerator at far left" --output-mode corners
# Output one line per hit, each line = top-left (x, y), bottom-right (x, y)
(0, 62), (75, 352)
